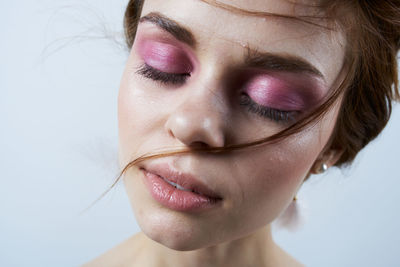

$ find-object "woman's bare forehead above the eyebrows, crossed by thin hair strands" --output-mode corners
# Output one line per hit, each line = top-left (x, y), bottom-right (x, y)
(142, 0), (345, 84)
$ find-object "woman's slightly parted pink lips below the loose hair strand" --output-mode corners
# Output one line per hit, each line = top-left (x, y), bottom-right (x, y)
(140, 164), (222, 211)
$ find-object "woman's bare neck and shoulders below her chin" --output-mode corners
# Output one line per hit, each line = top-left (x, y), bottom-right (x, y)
(83, 227), (304, 267)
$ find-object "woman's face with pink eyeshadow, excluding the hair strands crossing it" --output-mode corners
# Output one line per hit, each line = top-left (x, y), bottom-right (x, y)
(118, 0), (344, 250)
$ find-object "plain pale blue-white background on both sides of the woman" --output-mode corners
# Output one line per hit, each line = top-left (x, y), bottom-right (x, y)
(0, 0), (400, 267)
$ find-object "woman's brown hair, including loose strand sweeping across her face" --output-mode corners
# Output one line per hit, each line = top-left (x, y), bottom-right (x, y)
(114, 0), (400, 184)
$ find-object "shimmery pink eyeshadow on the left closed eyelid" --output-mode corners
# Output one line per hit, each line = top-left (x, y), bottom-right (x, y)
(138, 41), (192, 73)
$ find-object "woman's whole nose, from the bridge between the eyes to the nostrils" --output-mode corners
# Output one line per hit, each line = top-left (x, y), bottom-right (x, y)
(165, 68), (228, 147)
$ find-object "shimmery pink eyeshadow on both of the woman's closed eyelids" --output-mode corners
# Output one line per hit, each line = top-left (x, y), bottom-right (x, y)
(135, 25), (326, 112)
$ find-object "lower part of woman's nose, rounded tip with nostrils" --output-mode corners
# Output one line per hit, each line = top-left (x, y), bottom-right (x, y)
(165, 92), (226, 150)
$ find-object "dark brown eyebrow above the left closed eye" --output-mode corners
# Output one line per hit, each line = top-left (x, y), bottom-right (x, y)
(139, 12), (197, 48)
